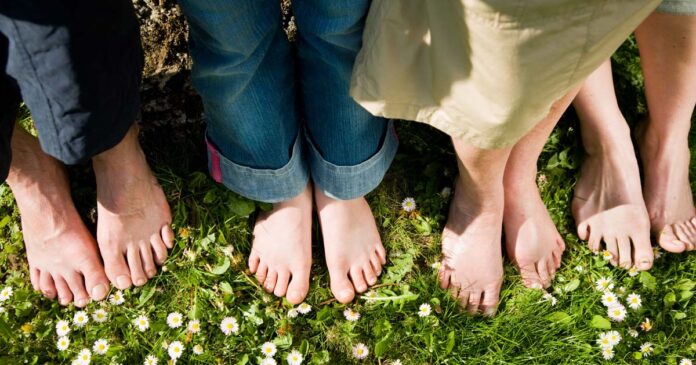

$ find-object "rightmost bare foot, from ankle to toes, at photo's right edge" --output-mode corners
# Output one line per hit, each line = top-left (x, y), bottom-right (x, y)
(637, 121), (696, 252)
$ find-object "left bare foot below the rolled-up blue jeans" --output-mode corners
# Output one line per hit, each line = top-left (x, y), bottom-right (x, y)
(249, 185), (312, 304)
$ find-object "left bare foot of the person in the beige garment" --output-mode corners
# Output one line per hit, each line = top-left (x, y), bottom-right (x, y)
(439, 179), (503, 316)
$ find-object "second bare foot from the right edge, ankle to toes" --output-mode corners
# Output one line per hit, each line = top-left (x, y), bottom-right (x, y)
(572, 128), (653, 270)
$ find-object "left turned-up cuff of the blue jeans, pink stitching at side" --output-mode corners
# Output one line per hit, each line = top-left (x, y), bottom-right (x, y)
(206, 134), (309, 203)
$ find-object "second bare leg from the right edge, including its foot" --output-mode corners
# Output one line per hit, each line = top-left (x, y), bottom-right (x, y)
(573, 60), (653, 270)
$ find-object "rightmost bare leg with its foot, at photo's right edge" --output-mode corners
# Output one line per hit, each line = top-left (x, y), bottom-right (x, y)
(635, 13), (696, 252)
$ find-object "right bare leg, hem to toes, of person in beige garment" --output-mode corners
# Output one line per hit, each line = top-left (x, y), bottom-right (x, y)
(503, 90), (577, 288)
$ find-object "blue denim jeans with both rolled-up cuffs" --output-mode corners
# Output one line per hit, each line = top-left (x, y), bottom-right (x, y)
(179, 0), (398, 203)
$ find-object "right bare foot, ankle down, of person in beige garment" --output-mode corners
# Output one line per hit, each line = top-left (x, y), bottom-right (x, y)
(503, 183), (565, 288)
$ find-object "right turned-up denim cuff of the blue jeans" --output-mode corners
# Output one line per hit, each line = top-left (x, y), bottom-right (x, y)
(305, 120), (399, 200)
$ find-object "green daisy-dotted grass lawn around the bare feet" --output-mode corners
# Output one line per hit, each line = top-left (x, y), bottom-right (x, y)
(0, 42), (696, 364)
